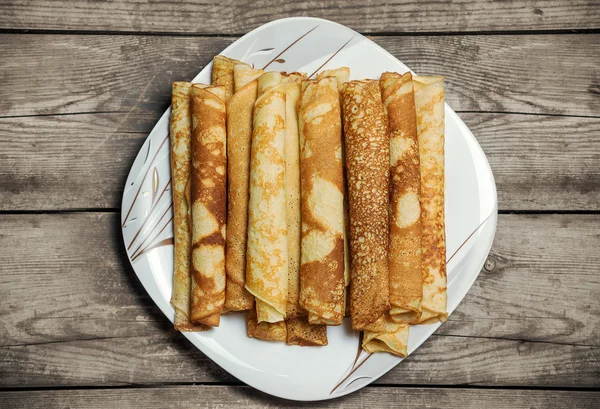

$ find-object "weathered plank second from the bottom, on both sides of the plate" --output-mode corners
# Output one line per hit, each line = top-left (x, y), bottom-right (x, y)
(0, 330), (600, 388)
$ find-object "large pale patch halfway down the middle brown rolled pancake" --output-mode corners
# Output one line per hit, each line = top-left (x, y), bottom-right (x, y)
(308, 177), (344, 234)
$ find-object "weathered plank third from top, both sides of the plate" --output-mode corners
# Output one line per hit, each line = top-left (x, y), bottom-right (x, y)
(0, 111), (600, 210)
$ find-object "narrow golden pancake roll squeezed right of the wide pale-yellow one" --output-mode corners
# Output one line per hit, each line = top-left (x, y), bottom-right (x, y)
(282, 73), (306, 318)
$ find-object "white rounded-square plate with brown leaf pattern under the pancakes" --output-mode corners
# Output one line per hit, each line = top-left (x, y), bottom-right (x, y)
(122, 18), (497, 400)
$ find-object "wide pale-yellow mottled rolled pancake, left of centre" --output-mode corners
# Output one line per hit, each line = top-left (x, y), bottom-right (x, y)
(245, 72), (288, 322)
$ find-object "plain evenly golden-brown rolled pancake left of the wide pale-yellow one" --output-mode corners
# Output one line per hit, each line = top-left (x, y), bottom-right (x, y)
(225, 81), (258, 311)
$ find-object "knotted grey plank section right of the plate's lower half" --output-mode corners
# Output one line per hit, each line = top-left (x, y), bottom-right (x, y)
(437, 215), (600, 347)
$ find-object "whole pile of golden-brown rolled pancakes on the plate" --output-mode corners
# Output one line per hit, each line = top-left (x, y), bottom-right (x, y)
(170, 56), (447, 356)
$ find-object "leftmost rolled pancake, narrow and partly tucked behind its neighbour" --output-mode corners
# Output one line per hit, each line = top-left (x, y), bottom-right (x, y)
(170, 82), (207, 331)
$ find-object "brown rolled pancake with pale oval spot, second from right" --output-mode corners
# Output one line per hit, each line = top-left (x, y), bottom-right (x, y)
(379, 72), (423, 324)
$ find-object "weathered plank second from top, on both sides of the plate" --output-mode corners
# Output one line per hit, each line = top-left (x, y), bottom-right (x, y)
(0, 34), (600, 118)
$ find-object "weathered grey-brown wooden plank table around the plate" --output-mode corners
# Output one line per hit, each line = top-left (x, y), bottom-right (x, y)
(0, 0), (600, 409)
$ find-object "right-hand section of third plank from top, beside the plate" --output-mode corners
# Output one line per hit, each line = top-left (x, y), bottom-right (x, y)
(459, 113), (600, 210)
